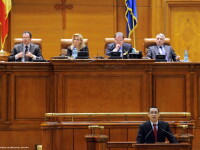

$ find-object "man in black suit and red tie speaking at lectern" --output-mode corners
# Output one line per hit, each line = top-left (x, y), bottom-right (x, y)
(137, 107), (178, 143)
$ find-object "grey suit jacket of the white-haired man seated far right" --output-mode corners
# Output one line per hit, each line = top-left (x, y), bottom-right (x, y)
(146, 45), (176, 61)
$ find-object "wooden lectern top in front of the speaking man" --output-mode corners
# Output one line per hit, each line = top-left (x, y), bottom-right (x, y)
(135, 143), (191, 150)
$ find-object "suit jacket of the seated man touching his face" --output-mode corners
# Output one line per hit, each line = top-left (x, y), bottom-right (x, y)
(106, 43), (132, 56)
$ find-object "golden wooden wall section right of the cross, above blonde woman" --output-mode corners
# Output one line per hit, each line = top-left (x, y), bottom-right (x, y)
(62, 0), (115, 57)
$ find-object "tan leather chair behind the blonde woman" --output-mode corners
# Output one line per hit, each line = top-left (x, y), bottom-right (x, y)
(60, 39), (88, 55)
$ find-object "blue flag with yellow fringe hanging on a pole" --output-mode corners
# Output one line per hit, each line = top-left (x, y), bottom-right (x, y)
(125, 0), (137, 38)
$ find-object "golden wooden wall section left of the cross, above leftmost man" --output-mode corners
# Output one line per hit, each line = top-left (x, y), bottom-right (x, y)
(11, 0), (62, 59)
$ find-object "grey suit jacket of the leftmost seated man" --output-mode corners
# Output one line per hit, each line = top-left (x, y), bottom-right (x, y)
(8, 43), (43, 62)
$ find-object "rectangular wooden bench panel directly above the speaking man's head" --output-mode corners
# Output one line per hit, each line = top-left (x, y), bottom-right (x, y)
(153, 75), (186, 112)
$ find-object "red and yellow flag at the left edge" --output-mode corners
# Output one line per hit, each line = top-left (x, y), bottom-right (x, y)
(0, 0), (12, 49)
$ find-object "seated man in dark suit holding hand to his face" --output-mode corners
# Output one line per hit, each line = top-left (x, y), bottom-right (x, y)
(106, 32), (132, 58)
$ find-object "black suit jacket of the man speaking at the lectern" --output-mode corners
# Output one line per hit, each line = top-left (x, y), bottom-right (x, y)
(137, 121), (177, 143)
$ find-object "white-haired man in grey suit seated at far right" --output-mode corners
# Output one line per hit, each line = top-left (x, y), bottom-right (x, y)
(146, 33), (180, 62)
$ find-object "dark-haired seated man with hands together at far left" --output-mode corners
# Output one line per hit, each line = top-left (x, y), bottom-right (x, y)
(8, 31), (43, 62)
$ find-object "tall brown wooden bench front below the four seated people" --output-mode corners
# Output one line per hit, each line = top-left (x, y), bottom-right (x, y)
(0, 60), (200, 150)
